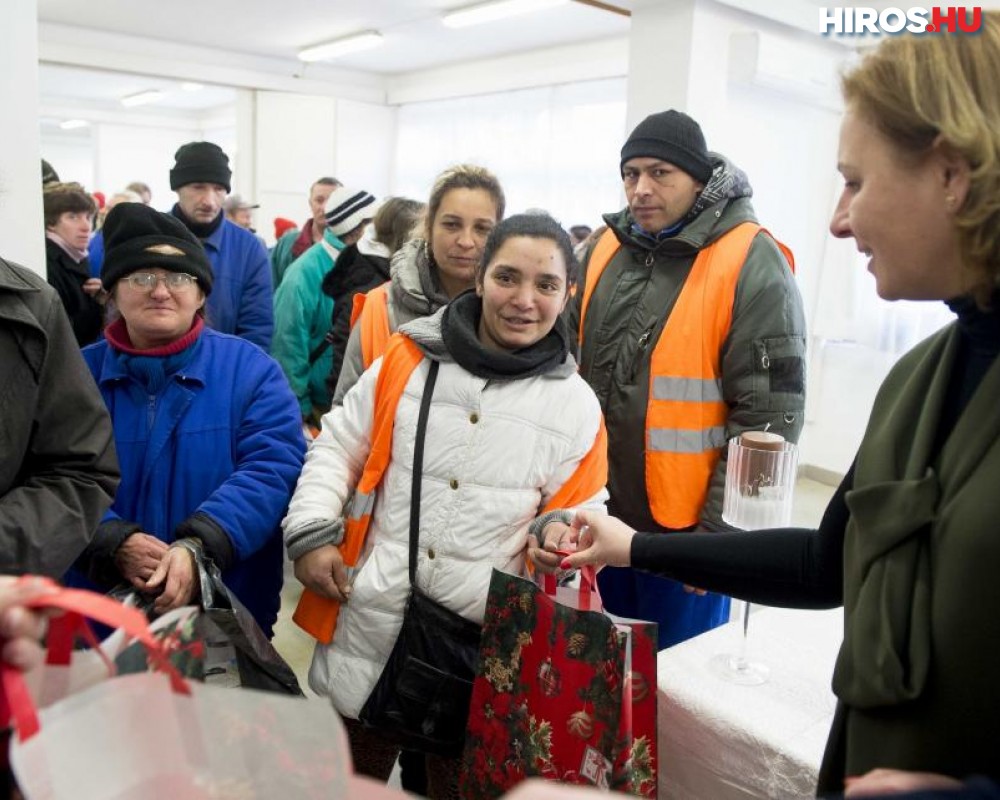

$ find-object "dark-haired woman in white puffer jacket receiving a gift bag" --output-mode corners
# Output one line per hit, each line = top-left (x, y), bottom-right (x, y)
(283, 215), (607, 797)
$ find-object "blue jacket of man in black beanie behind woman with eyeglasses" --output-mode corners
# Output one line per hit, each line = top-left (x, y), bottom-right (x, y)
(186, 214), (274, 351)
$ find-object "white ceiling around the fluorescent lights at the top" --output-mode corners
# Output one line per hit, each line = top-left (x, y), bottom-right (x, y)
(38, 0), (633, 74)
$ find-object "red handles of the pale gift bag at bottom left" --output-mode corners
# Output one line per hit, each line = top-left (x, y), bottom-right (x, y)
(0, 576), (191, 741)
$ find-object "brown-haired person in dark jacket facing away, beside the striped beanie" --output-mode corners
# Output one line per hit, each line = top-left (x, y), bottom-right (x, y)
(323, 197), (424, 397)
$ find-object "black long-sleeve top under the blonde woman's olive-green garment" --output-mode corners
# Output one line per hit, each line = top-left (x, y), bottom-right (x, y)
(631, 291), (1000, 608)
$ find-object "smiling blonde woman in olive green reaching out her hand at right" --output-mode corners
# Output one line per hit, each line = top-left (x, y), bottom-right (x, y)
(567, 12), (1000, 797)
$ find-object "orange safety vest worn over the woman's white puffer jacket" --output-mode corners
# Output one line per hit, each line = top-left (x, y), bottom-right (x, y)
(292, 334), (608, 644)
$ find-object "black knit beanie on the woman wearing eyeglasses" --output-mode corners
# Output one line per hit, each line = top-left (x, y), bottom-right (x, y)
(101, 203), (212, 295)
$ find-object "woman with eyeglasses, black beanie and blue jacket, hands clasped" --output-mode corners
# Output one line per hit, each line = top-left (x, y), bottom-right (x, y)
(77, 203), (305, 636)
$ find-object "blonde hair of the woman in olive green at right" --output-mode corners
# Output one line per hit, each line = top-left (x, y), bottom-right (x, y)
(841, 11), (1000, 307)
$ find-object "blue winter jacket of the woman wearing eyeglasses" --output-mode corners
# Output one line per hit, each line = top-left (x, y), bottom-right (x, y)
(83, 328), (305, 636)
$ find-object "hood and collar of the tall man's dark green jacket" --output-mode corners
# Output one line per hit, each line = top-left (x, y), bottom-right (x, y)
(604, 153), (757, 255)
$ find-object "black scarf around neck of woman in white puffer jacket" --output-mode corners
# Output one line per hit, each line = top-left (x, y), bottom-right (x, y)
(441, 289), (569, 380)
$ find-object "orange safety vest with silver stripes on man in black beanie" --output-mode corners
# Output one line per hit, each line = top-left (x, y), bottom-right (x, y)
(579, 222), (795, 529)
